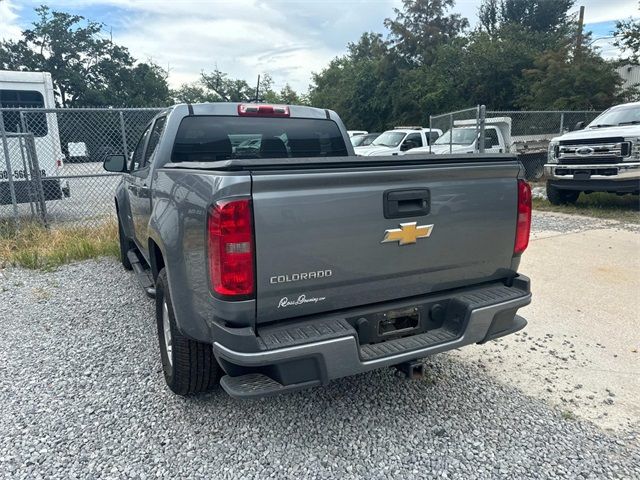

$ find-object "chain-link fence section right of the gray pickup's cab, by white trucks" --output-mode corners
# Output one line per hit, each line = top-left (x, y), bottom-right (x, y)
(429, 105), (601, 180)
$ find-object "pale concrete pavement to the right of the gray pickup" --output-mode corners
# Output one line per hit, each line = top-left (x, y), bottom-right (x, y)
(455, 213), (640, 431)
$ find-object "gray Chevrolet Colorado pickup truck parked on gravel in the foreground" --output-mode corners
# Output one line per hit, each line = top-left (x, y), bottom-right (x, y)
(104, 103), (531, 398)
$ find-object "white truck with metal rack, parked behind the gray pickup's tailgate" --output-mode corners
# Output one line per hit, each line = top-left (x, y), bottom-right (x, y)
(403, 117), (556, 180)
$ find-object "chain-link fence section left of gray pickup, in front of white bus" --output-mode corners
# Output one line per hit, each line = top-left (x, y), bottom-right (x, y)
(0, 108), (165, 225)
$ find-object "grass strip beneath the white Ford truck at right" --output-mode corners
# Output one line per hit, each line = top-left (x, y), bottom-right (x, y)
(533, 193), (640, 223)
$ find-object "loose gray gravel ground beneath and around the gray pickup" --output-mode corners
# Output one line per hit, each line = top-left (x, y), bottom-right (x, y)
(0, 216), (640, 479)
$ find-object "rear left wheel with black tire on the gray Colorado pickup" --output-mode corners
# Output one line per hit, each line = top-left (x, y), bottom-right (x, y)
(156, 268), (221, 395)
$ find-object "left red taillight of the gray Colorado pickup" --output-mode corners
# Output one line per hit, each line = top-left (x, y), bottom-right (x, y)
(207, 199), (254, 297)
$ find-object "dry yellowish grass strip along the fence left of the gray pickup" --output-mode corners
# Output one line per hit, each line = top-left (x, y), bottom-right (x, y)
(0, 222), (119, 270)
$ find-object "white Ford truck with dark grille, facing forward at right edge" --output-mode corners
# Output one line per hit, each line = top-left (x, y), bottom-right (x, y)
(545, 102), (640, 205)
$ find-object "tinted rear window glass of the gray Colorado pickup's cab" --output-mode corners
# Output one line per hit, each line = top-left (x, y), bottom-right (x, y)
(172, 116), (347, 162)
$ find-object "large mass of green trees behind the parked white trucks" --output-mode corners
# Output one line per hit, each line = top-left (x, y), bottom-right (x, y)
(309, 0), (619, 124)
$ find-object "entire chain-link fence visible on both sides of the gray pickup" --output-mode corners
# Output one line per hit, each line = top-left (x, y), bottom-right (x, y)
(0, 106), (599, 231)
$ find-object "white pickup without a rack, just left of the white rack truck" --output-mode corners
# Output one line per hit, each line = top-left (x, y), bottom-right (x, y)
(355, 127), (442, 157)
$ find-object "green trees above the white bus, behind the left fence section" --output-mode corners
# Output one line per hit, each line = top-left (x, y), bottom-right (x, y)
(0, 6), (169, 107)
